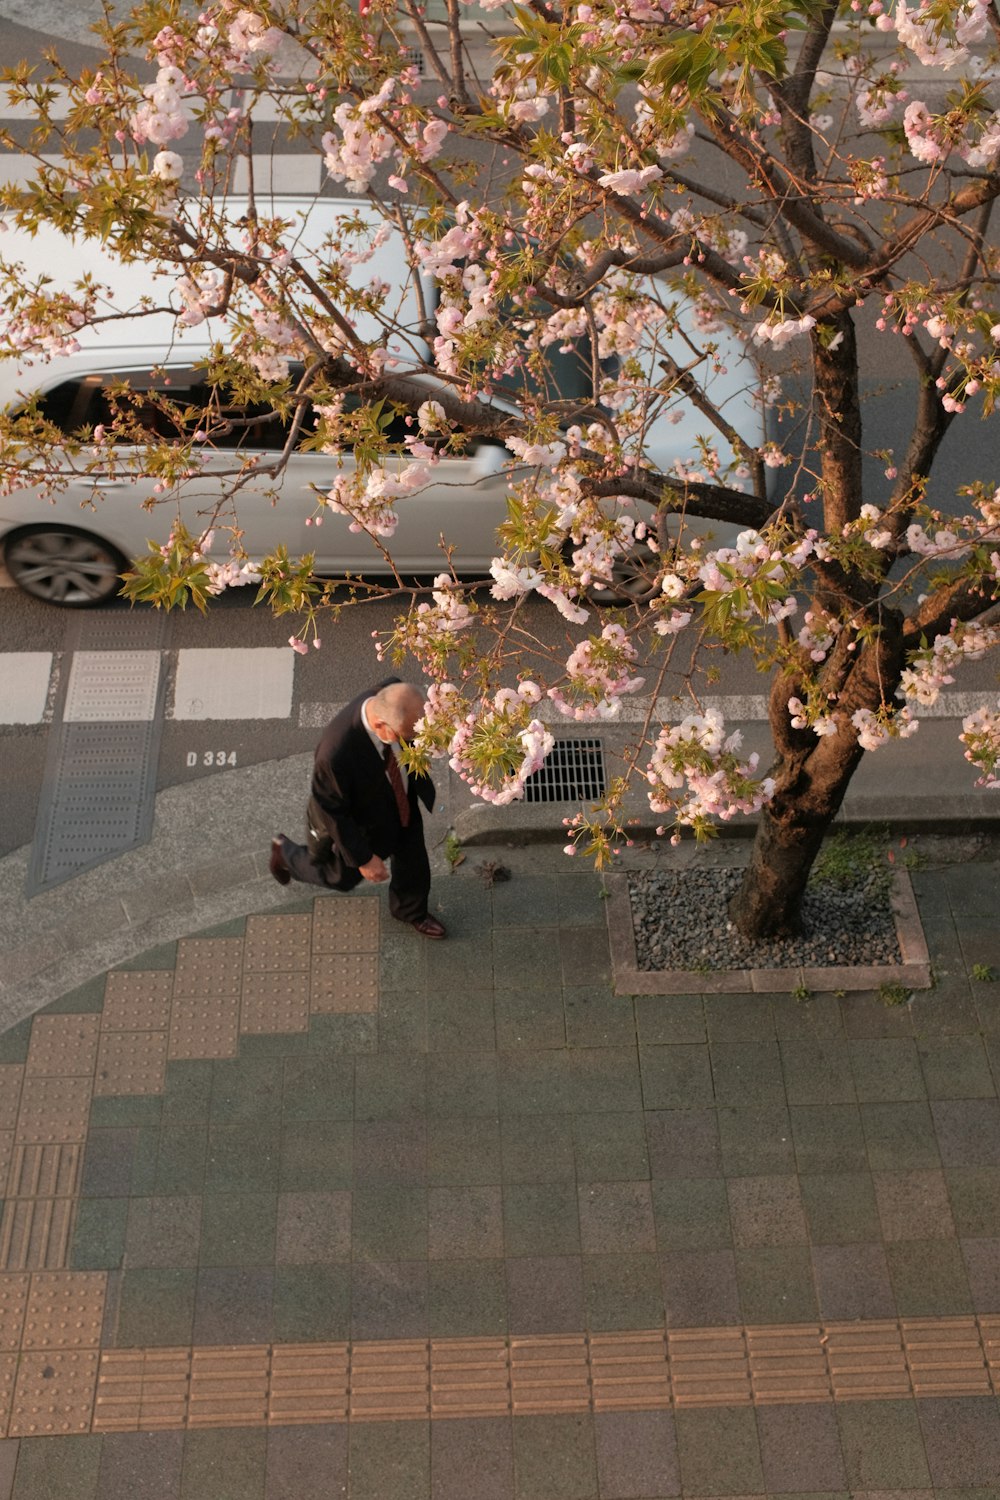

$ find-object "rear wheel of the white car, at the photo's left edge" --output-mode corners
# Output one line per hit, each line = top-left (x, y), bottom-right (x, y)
(3, 525), (129, 609)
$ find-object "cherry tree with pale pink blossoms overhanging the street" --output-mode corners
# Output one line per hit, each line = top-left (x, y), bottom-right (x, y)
(0, 0), (1000, 938)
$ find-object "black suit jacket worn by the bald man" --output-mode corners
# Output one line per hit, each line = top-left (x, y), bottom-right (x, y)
(309, 677), (435, 867)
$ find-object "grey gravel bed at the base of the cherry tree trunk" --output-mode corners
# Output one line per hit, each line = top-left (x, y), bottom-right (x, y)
(628, 866), (901, 971)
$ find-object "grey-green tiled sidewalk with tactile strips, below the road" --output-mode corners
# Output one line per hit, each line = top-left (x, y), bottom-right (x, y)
(0, 822), (1000, 1500)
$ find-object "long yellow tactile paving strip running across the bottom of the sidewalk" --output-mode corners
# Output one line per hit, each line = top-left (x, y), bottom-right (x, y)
(0, 1271), (1000, 1437)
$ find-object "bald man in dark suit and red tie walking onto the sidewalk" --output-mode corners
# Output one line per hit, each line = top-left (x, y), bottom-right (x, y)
(270, 678), (445, 938)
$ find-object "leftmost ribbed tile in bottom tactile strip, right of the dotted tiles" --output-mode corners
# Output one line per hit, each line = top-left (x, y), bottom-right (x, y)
(93, 1349), (192, 1433)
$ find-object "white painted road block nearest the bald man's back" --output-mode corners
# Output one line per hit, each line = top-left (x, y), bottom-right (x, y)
(168, 647), (295, 720)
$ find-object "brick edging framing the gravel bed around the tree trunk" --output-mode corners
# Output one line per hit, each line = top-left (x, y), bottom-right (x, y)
(604, 870), (934, 995)
